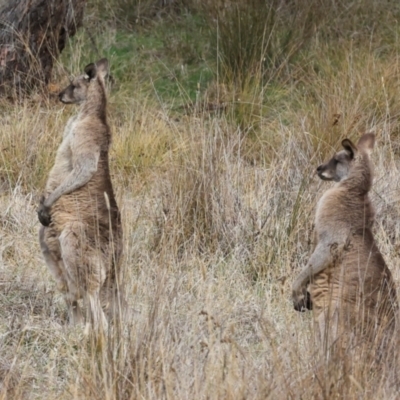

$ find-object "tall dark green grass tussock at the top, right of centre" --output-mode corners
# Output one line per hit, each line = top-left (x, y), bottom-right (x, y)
(203, 0), (314, 88)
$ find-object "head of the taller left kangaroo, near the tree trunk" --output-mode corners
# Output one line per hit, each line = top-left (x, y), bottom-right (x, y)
(58, 58), (108, 104)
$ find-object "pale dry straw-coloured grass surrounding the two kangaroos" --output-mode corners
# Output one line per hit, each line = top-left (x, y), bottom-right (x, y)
(0, 2), (400, 400)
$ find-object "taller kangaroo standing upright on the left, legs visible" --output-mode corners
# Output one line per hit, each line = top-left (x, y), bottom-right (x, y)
(38, 59), (122, 330)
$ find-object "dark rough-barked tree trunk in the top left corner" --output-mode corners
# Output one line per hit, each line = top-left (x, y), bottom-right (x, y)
(0, 0), (86, 97)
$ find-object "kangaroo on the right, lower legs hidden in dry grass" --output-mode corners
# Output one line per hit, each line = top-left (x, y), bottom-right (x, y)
(292, 133), (397, 356)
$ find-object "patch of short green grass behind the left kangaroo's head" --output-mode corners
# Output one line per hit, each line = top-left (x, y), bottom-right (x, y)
(62, 14), (214, 110)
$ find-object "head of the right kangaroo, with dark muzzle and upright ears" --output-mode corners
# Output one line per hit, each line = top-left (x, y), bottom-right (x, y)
(317, 133), (375, 182)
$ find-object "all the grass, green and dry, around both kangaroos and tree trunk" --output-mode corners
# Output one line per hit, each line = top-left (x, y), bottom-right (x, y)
(0, 0), (400, 400)
